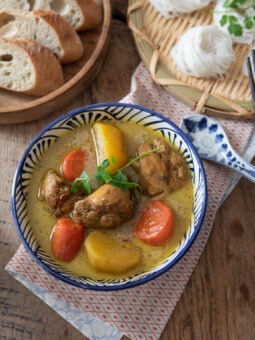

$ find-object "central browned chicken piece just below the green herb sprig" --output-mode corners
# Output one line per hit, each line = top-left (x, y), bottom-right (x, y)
(73, 184), (134, 228)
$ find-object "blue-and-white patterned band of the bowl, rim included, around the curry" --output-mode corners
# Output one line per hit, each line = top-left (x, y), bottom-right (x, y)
(11, 103), (207, 291)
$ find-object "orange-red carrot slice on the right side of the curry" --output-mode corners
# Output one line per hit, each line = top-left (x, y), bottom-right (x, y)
(135, 201), (174, 246)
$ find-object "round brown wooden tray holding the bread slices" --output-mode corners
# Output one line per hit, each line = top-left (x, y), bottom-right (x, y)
(0, 0), (111, 125)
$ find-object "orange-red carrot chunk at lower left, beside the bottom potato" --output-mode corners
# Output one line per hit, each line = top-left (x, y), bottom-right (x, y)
(51, 217), (84, 262)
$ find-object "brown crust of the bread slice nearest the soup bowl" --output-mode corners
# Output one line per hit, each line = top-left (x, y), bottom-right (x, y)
(0, 38), (64, 96)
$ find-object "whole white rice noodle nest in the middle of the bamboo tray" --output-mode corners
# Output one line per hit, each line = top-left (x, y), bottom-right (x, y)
(170, 25), (235, 78)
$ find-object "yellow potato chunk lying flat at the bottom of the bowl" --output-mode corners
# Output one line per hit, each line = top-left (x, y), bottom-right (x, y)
(85, 231), (141, 274)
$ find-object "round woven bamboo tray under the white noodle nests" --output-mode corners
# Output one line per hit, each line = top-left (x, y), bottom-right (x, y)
(128, 0), (255, 119)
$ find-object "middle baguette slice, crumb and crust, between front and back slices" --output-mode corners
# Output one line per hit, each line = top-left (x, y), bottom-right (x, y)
(0, 10), (83, 63)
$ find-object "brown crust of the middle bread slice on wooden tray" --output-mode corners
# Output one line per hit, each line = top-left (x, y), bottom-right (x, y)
(31, 9), (83, 63)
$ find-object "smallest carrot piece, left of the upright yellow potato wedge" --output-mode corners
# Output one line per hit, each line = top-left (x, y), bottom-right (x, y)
(62, 149), (88, 182)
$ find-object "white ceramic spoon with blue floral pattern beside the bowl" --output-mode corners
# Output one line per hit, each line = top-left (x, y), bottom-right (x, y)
(181, 114), (255, 183)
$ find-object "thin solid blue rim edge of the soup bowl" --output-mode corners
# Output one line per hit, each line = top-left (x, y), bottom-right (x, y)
(11, 102), (208, 291)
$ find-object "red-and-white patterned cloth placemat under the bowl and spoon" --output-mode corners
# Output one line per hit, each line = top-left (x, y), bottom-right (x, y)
(6, 64), (255, 340)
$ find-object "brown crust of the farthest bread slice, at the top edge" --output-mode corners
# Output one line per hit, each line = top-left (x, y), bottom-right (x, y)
(76, 0), (103, 31)
